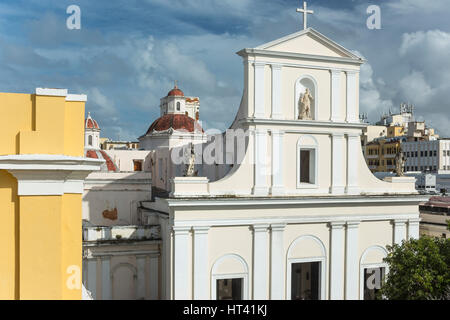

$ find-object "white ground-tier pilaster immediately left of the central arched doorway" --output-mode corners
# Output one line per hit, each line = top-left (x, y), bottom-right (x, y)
(270, 223), (286, 300)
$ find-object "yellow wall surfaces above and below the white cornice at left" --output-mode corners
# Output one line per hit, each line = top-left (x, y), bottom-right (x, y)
(0, 93), (85, 299)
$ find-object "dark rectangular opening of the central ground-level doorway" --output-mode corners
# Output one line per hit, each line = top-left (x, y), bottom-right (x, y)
(291, 262), (321, 300)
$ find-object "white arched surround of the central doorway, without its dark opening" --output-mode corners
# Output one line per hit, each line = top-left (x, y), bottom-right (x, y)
(286, 235), (327, 300)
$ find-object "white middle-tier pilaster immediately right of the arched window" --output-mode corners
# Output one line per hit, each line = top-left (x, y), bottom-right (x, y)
(331, 133), (346, 194)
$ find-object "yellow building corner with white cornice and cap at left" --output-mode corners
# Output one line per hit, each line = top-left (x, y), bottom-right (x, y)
(0, 88), (103, 299)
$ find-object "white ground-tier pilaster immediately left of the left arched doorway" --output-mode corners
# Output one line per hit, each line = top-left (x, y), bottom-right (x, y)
(193, 227), (210, 300)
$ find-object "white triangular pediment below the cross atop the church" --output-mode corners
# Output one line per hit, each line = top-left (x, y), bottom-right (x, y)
(255, 28), (364, 60)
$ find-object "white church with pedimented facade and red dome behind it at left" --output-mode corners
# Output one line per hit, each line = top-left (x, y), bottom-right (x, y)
(81, 23), (424, 300)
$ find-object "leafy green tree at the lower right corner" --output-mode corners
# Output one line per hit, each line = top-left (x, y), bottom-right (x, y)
(380, 237), (450, 300)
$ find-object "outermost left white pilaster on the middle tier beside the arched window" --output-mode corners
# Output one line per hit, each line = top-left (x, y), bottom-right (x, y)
(253, 129), (269, 196)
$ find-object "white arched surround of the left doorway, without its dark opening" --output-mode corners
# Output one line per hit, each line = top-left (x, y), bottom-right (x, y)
(211, 253), (249, 300)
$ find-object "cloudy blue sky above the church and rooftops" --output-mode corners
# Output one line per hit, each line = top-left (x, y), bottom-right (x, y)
(0, 0), (450, 140)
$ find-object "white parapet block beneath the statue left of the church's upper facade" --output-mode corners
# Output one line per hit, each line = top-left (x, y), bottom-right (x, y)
(170, 177), (209, 197)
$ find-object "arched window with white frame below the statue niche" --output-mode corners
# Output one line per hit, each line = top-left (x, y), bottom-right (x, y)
(297, 135), (319, 189)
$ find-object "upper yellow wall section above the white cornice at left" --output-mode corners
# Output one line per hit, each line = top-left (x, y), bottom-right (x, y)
(0, 93), (85, 157)
